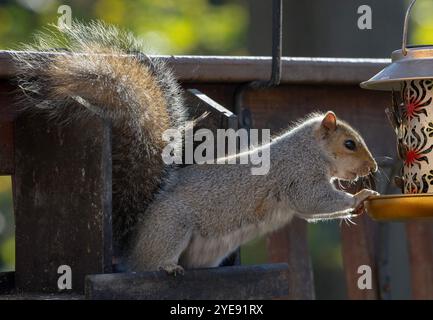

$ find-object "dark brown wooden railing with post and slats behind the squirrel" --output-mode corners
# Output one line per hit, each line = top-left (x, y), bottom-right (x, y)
(0, 51), (433, 299)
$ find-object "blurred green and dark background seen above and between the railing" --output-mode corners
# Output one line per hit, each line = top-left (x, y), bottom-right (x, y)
(0, 0), (426, 299)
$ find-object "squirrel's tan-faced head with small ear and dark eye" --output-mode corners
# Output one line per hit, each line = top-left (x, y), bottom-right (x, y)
(317, 111), (377, 180)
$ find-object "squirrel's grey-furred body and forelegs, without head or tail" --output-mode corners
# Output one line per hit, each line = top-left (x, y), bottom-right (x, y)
(129, 114), (376, 272)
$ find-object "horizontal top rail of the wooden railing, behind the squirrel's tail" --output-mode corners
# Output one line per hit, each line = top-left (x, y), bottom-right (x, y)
(0, 50), (391, 84)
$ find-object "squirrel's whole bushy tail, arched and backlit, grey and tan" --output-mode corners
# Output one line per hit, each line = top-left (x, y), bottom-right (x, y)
(14, 21), (185, 254)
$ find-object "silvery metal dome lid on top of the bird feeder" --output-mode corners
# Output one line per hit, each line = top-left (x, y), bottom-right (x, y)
(361, 46), (433, 91)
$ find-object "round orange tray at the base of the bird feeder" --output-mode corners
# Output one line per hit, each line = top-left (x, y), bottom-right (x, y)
(364, 194), (433, 221)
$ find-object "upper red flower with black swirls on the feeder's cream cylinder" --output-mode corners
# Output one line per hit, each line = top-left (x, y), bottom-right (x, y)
(402, 80), (432, 121)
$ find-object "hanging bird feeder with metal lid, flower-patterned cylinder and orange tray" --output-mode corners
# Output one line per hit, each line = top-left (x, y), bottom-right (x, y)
(361, 0), (433, 220)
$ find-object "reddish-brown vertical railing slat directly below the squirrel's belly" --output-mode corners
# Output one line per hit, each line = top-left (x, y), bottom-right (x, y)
(267, 218), (315, 300)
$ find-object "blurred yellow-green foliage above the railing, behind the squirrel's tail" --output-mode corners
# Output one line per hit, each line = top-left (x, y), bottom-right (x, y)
(0, 0), (248, 54)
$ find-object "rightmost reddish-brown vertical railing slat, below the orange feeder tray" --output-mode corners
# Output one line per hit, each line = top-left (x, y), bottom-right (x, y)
(406, 221), (433, 300)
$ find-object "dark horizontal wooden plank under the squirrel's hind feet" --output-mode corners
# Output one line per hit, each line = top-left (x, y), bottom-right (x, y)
(86, 263), (289, 300)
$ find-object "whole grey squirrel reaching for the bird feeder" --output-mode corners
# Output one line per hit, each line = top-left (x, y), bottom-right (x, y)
(15, 22), (377, 273)
